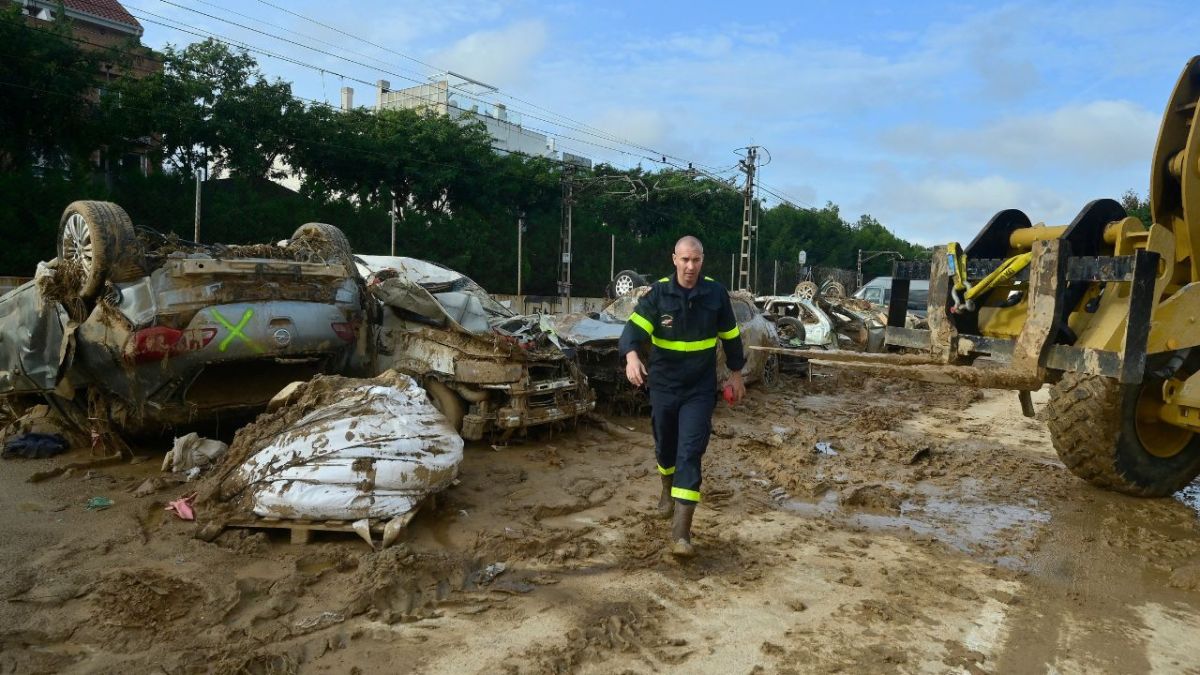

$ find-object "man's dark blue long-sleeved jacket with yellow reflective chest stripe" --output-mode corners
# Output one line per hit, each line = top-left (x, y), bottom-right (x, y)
(619, 276), (746, 393)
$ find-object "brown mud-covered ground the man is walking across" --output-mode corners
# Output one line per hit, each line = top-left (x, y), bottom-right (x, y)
(0, 370), (1200, 674)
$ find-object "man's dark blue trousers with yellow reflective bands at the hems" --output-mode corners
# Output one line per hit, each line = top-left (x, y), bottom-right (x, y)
(650, 387), (716, 503)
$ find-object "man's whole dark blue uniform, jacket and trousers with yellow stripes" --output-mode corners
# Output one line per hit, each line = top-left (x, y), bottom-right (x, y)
(620, 270), (746, 503)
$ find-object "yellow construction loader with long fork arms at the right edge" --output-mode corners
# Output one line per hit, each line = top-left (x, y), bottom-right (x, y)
(758, 56), (1200, 496)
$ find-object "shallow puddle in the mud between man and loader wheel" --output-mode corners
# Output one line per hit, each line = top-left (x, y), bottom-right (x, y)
(782, 480), (1046, 568)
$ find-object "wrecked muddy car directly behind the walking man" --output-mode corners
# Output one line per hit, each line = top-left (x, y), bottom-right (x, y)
(550, 286), (779, 410)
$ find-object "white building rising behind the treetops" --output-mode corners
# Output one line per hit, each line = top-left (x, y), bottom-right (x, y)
(355, 72), (592, 168)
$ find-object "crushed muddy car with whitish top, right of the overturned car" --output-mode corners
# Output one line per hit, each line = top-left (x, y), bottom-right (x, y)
(355, 256), (595, 441)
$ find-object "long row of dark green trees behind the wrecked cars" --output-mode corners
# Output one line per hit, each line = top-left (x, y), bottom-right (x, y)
(0, 22), (923, 295)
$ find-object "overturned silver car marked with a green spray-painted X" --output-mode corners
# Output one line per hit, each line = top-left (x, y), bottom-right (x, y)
(0, 202), (362, 434)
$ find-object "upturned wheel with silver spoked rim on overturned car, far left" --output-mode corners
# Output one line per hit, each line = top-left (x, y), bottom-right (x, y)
(58, 201), (145, 300)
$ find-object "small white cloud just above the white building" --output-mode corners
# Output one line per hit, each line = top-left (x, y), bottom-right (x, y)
(432, 19), (546, 86)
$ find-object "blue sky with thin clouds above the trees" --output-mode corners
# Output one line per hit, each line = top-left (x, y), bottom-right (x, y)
(131, 0), (1200, 245)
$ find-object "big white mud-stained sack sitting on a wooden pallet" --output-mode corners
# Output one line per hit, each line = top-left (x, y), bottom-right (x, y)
(197, 371), (463, 523)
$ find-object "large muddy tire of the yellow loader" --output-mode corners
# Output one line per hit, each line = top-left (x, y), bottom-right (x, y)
(1048, 372), (1200, 497)
